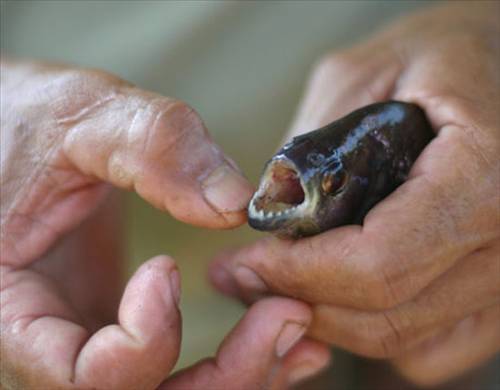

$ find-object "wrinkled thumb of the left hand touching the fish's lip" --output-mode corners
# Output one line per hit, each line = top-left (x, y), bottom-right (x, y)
(63, 71), (252, 228)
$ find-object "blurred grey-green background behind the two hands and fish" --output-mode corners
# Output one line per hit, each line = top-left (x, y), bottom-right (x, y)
(1, 0), (492, 389)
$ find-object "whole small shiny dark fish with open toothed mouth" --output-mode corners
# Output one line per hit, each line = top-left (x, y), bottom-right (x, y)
(248, 102), (434, 238)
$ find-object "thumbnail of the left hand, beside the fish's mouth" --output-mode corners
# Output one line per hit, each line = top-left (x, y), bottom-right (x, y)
(202, 163), (253, 213)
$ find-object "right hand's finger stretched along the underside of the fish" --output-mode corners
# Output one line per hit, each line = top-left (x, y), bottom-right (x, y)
(212, 120), (496, 309)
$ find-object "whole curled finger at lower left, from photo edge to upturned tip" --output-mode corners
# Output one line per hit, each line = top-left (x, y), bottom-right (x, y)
(0, 256), (181, 390)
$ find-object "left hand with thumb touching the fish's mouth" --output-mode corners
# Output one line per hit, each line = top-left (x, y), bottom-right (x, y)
(0, 62), (328, 390)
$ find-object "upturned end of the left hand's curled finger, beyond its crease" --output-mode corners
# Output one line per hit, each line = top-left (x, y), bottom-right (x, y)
(75, 256), (181, 389)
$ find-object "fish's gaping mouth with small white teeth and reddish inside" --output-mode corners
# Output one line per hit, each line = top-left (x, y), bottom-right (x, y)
(248, 157), (311, 225)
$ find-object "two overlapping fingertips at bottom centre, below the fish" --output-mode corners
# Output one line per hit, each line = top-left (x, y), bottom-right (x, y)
(160, 298), (329, 390)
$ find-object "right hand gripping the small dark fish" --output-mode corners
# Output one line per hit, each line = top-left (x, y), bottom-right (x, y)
(211, 2), (500, 384)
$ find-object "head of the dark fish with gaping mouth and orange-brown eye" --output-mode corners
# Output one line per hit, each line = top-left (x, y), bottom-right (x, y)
(248, 137), (351, 237)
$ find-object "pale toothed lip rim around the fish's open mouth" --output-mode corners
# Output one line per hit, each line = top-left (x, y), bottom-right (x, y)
(248, 155), (315, 230)
